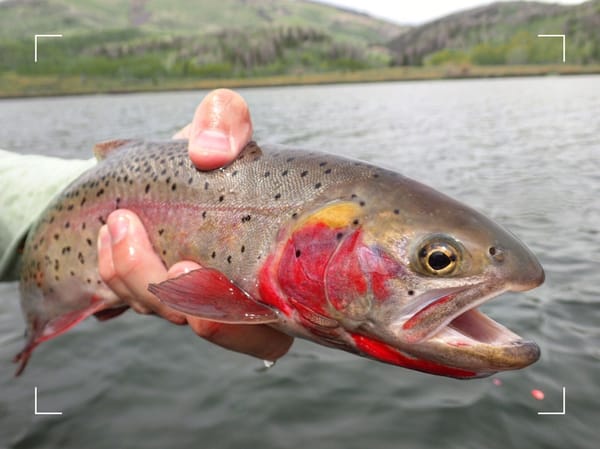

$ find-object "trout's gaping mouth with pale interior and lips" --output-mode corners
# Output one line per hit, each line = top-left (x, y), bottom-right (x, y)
(394, 284), (540, 375)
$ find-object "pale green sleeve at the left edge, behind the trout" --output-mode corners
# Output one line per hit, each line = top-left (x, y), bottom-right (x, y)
(0, 150), (95, 281)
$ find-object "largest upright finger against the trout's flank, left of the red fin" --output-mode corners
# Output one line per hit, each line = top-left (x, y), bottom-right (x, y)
(107, 209), (185, 324)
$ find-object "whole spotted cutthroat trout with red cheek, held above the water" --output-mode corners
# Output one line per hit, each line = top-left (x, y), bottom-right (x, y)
(15, 141), (544, 378)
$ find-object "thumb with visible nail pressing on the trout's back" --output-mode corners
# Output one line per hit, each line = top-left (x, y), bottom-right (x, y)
(188, 89), (252, 170)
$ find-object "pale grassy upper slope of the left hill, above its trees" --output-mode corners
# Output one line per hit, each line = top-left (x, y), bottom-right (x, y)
(0, 0), (403, 44)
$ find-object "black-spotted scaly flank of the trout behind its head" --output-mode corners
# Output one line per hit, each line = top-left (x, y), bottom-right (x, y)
(23, 141), (381, 300)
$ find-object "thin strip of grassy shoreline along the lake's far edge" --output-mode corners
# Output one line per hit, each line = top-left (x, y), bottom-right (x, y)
(0, 64), (600, 99)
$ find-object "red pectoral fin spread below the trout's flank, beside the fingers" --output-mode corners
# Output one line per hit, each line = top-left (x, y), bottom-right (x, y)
(148, 268), (279, 324)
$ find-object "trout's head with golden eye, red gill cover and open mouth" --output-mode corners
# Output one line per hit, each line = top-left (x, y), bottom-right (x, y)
(326, 180), (544, 378)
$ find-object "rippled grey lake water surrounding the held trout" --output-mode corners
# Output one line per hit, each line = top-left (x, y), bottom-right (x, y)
(0, 76), (600, 449)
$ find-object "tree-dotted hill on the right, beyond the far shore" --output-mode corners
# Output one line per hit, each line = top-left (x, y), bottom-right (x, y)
(389, 0), (600, 65)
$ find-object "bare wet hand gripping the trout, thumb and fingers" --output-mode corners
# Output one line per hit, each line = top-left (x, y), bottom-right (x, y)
(98, 89), (293, 360)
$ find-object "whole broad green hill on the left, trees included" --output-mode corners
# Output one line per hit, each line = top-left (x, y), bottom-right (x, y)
(0, 0), (404, 80)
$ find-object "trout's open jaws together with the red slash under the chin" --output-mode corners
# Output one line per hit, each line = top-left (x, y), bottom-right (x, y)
(352, 267), (543, 379)
